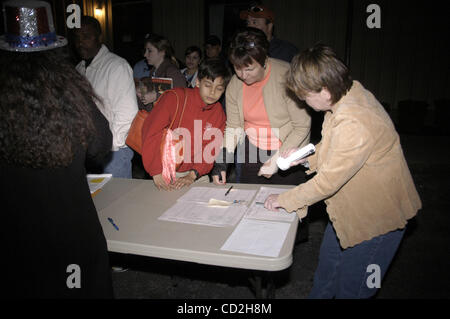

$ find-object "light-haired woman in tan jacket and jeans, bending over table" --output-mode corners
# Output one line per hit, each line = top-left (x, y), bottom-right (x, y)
(265, 45), (422, 298)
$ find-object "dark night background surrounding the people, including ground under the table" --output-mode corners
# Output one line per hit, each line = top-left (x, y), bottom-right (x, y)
(0, 0), (450, 299)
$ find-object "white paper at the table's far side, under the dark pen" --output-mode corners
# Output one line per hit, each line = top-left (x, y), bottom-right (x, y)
(177, 187), (256, 204)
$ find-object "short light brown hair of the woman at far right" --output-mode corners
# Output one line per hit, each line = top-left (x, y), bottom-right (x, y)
(286, 44), (353, 104)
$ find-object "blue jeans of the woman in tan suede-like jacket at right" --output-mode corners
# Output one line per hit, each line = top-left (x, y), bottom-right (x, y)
(308, 223), (405, 299)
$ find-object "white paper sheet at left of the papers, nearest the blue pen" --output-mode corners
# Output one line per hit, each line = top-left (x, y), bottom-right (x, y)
(158, 202), (247, 227)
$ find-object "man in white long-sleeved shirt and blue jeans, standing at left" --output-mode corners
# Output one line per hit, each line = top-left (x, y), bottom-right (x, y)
(74, 16), (138, 178)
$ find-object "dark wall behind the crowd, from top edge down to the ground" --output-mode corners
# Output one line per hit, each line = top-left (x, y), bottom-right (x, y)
(0, 0), (450, 135)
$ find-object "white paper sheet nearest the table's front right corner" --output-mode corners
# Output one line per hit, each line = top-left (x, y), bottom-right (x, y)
(221, 218), (290, 257)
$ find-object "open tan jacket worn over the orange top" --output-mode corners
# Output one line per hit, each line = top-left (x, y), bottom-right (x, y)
(223, 58), (311, 158)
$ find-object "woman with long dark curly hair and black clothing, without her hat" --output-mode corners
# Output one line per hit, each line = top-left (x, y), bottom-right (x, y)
(0, 48), (113, 298)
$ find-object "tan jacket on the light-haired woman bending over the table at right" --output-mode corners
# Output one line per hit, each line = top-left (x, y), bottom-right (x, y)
(278, 81), (422, 249)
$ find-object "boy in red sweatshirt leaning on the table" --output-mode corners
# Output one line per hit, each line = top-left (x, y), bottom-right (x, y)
(142, 59), (231, 190)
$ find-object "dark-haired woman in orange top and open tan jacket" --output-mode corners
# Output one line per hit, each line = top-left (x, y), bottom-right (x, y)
(212, 28), (311, 185)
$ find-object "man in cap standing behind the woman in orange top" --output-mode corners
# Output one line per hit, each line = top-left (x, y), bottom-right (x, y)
(240, 5), (298, 63)
